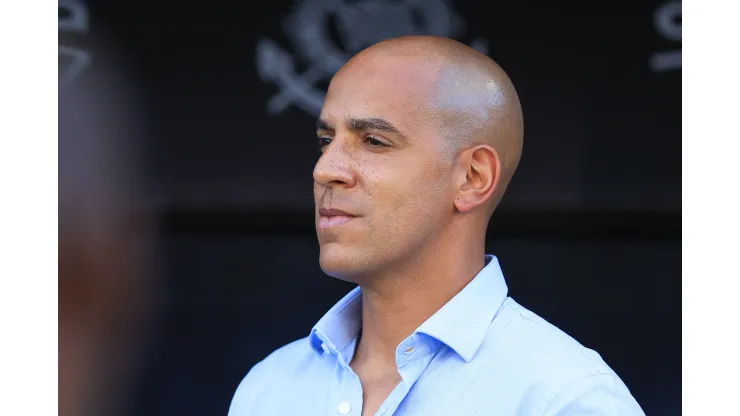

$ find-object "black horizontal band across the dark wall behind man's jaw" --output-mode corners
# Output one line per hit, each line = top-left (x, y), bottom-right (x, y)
(160, 208), (681, 239)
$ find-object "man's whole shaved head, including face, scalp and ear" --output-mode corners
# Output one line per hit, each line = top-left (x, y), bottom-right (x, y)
(313, 37), (522, 282)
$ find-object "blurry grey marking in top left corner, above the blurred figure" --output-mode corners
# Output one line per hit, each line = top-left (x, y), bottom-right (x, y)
(59, 0), (91, 83)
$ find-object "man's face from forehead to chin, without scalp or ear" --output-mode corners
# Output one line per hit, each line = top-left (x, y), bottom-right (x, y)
(313, 57), (455, 281)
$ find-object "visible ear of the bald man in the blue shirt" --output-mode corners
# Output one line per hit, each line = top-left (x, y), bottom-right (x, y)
(455, 144), (501, 212)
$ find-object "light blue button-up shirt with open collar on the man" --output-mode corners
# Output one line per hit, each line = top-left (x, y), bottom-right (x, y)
(229, 256), (644, 416)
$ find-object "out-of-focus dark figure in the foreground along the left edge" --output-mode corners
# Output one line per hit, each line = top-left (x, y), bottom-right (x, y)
(59, 51), (152, 416)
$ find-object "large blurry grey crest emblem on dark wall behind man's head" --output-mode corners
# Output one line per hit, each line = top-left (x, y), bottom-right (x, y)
(257, 0), (488, 116)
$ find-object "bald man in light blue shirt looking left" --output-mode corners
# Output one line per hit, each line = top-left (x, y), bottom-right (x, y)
(229, 37), (643, 416)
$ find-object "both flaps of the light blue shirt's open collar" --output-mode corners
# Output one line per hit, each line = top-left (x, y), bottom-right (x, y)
(309, 255), (508, 362)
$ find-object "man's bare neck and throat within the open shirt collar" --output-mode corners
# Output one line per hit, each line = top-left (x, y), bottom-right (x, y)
(352, 247), (485, 367)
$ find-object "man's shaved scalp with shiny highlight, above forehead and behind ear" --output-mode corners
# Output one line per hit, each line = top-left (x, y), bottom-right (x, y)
(337, 36), (524, 212)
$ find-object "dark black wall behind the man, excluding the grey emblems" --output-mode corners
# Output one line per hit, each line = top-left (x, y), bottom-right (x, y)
(60, 0), (681, 415)
